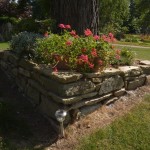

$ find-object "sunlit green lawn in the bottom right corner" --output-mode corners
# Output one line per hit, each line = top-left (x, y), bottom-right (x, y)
(78, 95), (150, 150)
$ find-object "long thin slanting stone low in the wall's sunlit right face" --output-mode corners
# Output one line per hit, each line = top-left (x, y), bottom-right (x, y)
(69, 94), (112, 110)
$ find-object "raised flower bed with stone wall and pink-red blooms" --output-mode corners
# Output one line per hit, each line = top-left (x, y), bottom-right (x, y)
(0, 25), (150, 124)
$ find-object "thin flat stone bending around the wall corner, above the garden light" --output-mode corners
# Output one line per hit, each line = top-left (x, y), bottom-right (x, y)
(48, 92), (97, 105)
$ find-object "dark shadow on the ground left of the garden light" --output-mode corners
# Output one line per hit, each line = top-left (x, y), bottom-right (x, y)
(0, 70), (58, 150)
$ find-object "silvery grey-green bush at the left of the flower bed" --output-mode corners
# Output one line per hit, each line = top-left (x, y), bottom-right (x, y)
(10, 31), (42, 59)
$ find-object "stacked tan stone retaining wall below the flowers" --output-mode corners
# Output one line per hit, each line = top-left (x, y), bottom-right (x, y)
(0, 51), (150, 124)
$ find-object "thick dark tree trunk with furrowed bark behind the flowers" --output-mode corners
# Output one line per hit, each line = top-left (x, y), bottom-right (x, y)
(53, 0), (99, 35)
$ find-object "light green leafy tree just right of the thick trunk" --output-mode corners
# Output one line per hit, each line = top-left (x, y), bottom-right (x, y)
(99, 0), (129, 33)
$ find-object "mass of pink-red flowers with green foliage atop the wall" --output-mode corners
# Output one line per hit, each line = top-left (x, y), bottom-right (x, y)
(36, 24), (134, 72)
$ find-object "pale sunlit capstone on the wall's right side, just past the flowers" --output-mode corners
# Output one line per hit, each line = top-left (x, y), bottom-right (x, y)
(119, 66), (142, 77)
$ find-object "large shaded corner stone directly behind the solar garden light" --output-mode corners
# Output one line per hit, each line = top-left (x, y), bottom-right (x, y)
(38, 95), (70, 124)
